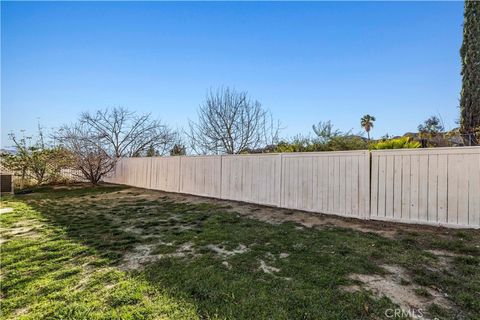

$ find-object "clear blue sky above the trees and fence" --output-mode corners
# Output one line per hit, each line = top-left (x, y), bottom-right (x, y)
(1, 2), (463, 146)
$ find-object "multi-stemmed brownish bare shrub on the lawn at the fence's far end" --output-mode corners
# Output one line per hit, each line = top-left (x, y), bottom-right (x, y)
(56, 123), (117, 185)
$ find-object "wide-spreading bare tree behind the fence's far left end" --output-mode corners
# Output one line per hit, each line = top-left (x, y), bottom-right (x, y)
(80, 107), (175, 158)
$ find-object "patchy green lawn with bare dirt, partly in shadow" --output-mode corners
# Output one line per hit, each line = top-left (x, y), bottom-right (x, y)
(0, 185), (480, 319)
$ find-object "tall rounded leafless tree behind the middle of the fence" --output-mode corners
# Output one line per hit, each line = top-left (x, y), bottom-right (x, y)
(187, 87), (280, 154)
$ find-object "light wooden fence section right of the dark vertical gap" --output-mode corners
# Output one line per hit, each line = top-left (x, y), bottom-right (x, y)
(370, 147), (480, 228)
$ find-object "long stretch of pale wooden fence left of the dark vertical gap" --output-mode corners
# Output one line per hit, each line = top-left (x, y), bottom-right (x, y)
(105, 151), (370, 218)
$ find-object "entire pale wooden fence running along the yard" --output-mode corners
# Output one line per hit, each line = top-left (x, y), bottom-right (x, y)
(105, 147), (480, 228)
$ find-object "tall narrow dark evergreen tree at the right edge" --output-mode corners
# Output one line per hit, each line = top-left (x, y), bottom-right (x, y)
(460, 1), (480, 142)
